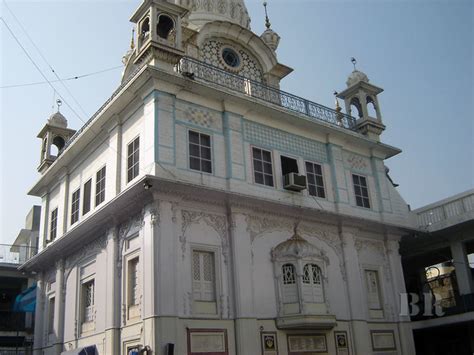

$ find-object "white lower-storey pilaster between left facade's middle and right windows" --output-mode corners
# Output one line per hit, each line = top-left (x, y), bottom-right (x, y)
(105, 225), (121, 354)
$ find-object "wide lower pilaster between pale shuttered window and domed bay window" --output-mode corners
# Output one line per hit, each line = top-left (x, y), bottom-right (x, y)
(230, 211), (260, 355)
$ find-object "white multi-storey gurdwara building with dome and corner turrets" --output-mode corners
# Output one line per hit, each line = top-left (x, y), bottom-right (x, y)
(22, 0), (414, 355)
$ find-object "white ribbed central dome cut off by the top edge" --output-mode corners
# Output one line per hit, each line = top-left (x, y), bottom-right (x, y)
(175, 0), (250, 29)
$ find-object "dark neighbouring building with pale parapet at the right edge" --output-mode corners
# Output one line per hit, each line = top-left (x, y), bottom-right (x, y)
(401, 190), (474, 355)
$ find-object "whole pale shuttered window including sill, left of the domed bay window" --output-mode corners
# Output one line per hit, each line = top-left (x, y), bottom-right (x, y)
(192, 250), (217, 314)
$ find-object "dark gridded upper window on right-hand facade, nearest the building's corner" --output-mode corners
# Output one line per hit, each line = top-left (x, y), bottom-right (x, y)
(189, 131), (212, 174)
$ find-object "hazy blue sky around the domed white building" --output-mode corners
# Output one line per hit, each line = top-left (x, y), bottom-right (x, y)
(0, 0), (474, 243)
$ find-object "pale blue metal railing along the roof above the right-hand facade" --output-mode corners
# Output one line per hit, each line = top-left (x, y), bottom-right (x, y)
(177, 57), (356, 130)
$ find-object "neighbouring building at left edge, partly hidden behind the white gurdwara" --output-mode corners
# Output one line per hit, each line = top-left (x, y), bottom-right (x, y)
(0, 206), (41, 355)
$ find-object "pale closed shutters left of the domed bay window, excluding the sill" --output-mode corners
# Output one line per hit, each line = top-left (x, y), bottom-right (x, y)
(193, 251), (216, 302)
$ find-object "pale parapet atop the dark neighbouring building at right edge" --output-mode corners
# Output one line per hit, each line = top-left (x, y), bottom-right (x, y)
(413, 190), (474, 232)
